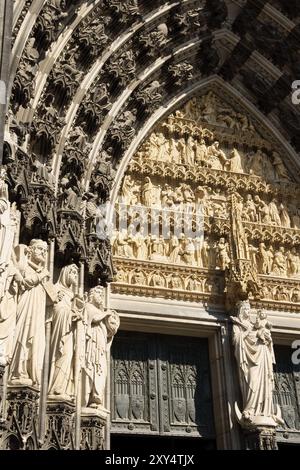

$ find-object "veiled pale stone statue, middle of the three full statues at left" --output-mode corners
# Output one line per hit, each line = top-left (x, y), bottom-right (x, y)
(48, 264), (83, 400)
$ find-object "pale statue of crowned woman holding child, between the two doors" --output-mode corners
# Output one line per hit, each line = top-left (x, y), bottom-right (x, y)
(231, 300), (280, 427)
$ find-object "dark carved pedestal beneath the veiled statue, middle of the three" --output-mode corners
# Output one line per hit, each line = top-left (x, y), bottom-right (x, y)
(42, 398), (75, 450)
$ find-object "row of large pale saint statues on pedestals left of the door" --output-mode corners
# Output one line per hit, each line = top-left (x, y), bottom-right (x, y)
(0, 240), (119, 407)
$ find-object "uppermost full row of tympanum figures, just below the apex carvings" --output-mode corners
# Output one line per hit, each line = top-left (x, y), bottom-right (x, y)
(136, 132), (291, 181)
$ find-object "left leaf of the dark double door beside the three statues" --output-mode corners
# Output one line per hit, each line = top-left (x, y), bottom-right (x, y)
(111, 333), (159, 434)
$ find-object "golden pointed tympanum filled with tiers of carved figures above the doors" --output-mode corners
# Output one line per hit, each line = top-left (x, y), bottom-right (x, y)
(112, 92), (300, 310)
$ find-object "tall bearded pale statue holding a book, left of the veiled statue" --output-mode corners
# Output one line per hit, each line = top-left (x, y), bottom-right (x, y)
(9, 239), (49, 387)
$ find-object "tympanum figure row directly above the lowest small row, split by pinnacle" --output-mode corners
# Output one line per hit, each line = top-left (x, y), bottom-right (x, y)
(112, 226), (300, 278)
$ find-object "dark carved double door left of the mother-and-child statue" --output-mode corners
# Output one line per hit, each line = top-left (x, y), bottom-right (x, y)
(111, 332), (214, 438)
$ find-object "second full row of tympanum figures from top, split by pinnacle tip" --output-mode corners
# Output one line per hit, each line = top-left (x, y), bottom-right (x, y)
(119, 175), (300, 229)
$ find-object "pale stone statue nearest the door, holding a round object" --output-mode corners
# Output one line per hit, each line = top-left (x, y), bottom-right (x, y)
(82, 286), (120, 408)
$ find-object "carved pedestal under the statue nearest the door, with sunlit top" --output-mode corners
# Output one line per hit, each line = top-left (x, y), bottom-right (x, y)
(80, 407), (109, 450)
